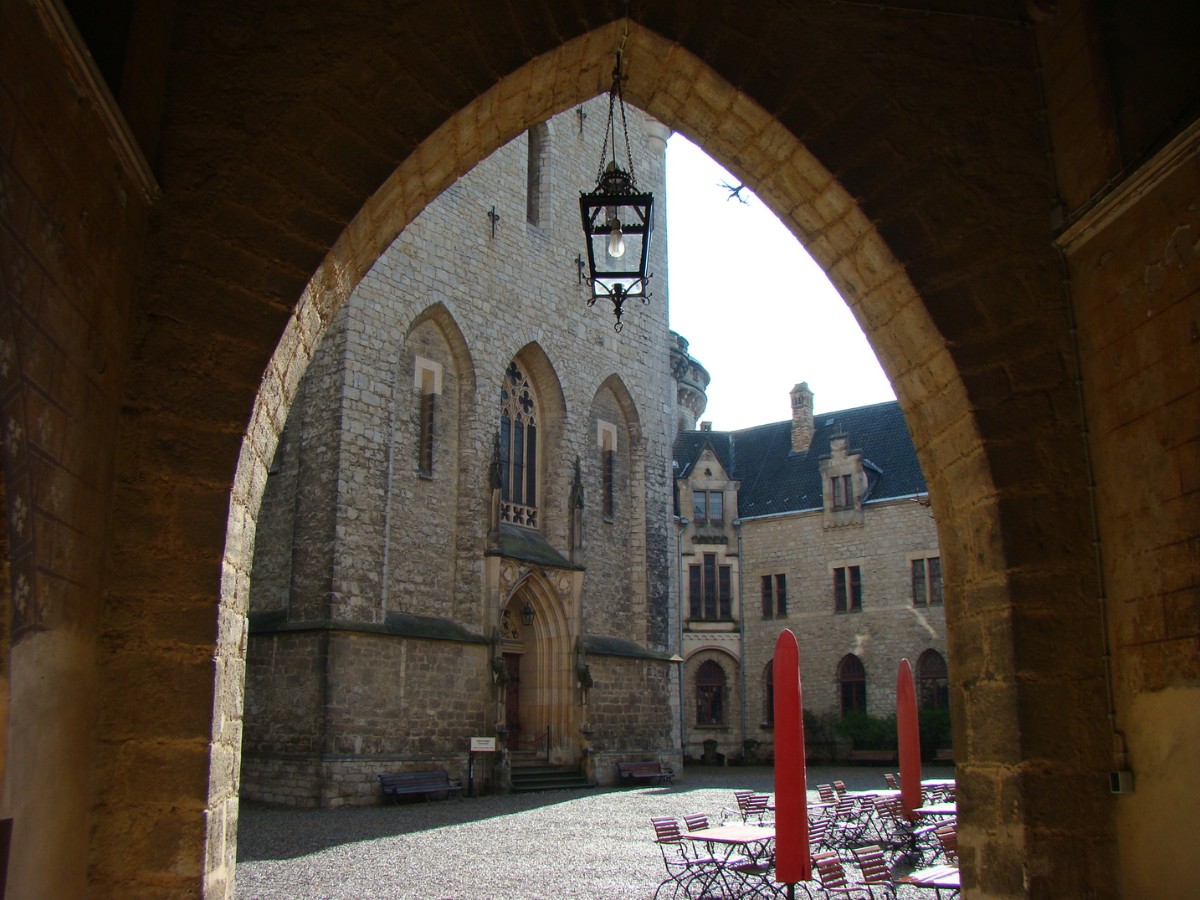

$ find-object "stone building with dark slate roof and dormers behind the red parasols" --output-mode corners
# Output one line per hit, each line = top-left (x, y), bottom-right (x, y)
(674, 369), (948, 761)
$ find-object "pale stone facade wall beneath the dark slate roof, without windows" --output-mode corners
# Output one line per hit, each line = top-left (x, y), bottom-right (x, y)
(682, 499), (947, 757)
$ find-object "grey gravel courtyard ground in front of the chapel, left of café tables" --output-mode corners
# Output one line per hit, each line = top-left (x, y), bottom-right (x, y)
(236, 767), (953, 900)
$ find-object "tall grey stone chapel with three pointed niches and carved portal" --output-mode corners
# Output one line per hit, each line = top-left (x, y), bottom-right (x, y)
(241, 96), (678, 805)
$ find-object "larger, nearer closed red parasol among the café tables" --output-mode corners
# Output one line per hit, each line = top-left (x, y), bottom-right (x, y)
(774, 629), (812, 898)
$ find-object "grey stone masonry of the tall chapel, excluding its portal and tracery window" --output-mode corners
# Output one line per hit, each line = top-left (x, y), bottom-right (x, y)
(244, 97), (674, 805)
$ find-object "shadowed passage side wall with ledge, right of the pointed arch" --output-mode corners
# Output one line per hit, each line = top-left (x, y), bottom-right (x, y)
(1063, 126), (1200, 896)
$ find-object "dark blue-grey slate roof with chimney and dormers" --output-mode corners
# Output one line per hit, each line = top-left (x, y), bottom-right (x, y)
(674, 401), (928, 518)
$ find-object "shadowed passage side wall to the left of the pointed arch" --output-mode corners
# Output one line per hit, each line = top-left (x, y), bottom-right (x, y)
(0, 2), (153, 896)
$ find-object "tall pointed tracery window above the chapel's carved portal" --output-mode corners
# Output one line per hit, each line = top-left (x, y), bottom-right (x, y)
(500, 361), (538, 528)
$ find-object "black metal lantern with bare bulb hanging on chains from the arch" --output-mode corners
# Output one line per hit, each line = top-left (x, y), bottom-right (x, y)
(580, 53), (654, 331)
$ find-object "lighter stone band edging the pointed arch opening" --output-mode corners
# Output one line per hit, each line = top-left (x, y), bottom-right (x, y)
(209, 22), (1096, 897)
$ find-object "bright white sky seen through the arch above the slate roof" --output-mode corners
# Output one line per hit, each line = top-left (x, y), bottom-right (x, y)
(667, 134), (895, 431)
